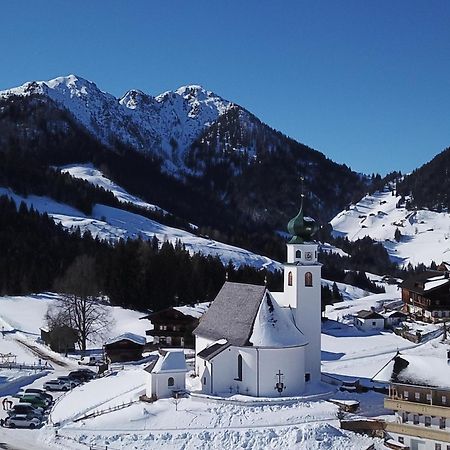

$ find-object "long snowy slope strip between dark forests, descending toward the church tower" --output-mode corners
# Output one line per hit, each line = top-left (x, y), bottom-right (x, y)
(0, 188), (281, 270)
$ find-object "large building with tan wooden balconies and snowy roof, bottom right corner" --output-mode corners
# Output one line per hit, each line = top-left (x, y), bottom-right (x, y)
(375, 354), (450, 450)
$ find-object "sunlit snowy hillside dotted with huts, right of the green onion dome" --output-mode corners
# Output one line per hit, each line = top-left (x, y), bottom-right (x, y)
(330, 190), (450, 266)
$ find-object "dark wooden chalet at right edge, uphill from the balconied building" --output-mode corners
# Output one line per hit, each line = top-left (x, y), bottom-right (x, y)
(401, 266), (450, 322)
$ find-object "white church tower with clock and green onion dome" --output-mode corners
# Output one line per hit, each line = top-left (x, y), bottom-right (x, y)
(284, 194), (322, 382)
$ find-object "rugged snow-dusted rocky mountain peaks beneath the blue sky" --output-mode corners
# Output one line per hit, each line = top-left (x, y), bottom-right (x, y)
(0, 75), (232, 173)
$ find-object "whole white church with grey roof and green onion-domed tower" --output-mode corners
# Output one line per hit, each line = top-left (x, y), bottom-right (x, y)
(194, 202), (321, 397)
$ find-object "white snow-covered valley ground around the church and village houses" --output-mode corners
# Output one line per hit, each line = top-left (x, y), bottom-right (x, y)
(0, 286), (428, 450)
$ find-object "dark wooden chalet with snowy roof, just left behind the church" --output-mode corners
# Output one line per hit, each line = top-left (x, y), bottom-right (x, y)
(141, 303), (209, 348)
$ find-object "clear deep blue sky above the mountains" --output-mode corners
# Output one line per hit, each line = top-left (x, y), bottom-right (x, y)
(0, 0), (450, 173)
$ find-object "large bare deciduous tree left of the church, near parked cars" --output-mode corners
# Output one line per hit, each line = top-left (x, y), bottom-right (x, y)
(46, 255), (113, 351)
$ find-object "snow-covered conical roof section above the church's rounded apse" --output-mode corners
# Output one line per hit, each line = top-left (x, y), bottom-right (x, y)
(249, 291), (308, 348)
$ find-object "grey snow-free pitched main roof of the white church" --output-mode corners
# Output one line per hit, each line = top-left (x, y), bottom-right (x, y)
(193, 281), (266, 347)
